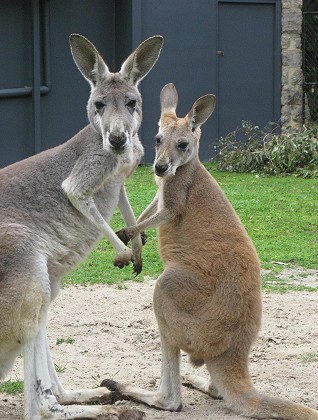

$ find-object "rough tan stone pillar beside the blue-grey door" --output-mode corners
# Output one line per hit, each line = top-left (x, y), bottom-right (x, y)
(281, 0), (303, 132)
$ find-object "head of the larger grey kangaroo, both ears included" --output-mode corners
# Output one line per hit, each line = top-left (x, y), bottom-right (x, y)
(70, 34), (163, 153)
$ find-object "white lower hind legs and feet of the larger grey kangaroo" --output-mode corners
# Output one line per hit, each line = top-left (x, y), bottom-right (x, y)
(19, 255), (143, 420)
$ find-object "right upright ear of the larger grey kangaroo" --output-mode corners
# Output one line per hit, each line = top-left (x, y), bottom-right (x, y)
(120, 35), (163, 85)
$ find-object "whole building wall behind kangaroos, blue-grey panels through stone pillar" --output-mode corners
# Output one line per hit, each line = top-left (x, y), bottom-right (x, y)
(0, 0), (284, 167)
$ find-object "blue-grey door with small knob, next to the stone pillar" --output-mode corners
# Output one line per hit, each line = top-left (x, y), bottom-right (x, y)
(217, 0), (280, 137)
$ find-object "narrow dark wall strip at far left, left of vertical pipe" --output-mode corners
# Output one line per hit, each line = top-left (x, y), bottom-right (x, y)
(0, 0), (34, 167)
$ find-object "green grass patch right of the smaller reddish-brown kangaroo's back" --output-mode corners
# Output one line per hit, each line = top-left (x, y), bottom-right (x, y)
(212, 167), (318, 268)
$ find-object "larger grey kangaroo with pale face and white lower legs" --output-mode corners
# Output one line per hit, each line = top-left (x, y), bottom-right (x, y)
(0, 34), (163, 420)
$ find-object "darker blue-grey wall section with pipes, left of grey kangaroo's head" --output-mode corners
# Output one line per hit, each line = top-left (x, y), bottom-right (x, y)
(0, 0), (115, 167)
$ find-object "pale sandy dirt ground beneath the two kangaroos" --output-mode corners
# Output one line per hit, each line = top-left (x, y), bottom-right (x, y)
(0, 271), (318, 420)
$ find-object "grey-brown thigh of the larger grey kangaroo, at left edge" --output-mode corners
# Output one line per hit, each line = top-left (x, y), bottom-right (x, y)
(0, 224), (42, 379)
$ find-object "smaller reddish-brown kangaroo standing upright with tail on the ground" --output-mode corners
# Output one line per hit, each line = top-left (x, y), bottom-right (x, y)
(102, 84), (318, 420)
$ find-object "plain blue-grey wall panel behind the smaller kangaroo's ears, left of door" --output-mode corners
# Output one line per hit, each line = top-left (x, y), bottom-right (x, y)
(133, 0), (217, 162)
